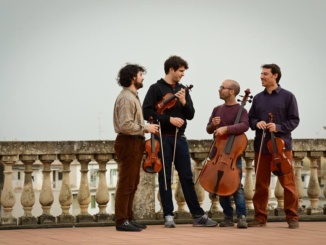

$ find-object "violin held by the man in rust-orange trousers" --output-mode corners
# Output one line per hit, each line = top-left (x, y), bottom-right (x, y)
(267, 113), (293, 176)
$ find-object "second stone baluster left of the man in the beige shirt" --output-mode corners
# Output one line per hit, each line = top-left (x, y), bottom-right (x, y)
(76, 154), (94, 223)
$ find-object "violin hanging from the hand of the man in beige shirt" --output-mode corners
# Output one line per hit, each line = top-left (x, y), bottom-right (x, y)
(142, 117), (162, 174)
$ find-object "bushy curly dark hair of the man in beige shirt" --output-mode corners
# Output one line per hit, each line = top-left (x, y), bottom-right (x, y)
(117, 63), (146, 87)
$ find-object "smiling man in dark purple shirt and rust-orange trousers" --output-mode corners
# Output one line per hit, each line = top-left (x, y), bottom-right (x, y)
(248, 64), (300, 229)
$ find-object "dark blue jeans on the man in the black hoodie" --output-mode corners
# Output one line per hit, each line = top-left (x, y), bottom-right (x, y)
(158, 135), (205, 217)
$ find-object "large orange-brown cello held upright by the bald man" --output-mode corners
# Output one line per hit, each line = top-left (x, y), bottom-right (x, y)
(198, 89), (252, 196)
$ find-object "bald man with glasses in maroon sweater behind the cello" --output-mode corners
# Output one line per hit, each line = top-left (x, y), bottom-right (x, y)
(206, 80), (249, 228)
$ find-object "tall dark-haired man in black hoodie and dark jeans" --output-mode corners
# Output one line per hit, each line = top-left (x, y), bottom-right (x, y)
(143, 56), (217, 228)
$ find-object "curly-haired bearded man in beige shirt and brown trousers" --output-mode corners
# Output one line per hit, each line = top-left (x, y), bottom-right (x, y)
(113, 64), (158, 231)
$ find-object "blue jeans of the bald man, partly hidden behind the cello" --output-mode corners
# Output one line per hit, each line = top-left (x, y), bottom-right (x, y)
(220, 157), (247, 217)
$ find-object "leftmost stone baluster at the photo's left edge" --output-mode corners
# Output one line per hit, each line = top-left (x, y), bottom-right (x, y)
(0, 155), (18, 225)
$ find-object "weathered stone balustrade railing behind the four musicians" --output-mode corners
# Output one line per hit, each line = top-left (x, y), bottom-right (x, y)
(0, 139), (326, 229)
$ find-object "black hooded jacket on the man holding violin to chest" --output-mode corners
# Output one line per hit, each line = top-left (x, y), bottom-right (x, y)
(143, 79), (195, 135)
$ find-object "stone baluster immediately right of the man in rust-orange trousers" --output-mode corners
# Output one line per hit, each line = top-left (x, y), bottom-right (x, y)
(293, 152), (307, 213)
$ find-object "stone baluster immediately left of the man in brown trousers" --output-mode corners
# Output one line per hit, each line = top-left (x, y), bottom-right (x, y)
(94, 154), (112, 222)
